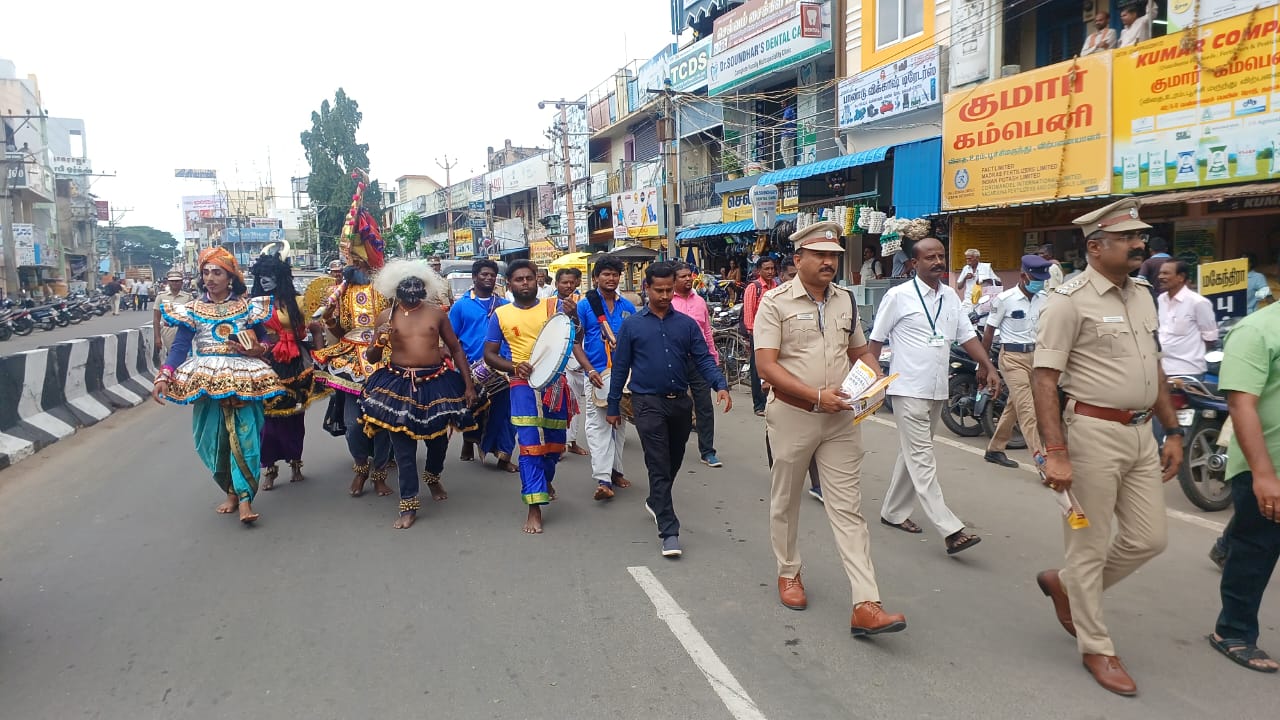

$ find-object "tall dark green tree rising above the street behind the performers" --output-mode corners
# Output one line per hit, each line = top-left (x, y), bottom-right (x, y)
(301, 87), (383, 254)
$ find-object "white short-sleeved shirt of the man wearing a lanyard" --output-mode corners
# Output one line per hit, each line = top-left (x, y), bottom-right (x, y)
(870, 278), (977, 400)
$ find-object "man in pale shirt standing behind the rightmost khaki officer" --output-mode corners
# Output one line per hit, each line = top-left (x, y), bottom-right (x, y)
(1156, 260), (1217, 377)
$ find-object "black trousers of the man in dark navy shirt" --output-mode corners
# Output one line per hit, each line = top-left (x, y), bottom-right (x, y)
(631, 392), (694, 538)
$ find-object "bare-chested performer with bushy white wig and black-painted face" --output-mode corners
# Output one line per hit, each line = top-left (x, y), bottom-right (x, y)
(360, 260), (476, 529)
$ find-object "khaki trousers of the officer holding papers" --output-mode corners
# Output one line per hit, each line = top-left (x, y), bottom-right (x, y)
(765, 397), (879, 605)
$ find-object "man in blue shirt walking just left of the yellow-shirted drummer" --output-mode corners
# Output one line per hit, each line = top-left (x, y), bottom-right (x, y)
(449, 260), (517, 473)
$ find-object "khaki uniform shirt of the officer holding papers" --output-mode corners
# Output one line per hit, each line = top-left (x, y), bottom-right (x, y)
(754, 279), (867, 388)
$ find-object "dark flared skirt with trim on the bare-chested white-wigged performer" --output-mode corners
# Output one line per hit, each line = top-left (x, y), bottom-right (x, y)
(360, 365), (476, 439)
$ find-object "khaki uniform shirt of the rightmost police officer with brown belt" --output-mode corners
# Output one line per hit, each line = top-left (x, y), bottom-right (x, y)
(1036, 266), (1160, 411)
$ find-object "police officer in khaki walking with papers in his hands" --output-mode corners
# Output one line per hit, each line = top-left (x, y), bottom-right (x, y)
(755, 223), (906, 637)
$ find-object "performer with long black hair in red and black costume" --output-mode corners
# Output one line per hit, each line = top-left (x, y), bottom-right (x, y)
(253, 249), (315, 491)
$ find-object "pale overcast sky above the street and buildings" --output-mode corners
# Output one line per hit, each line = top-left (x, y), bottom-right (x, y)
(0, 0), (672, 238)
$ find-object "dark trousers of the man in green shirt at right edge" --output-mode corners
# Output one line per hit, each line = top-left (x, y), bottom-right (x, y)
(1215, 473), (1280, 644)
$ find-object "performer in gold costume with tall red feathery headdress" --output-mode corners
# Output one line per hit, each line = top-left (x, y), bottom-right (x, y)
(311, 193), (392, 497)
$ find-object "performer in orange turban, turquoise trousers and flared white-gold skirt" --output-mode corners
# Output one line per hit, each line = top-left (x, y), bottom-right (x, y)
(151, 247), (284, 525)
